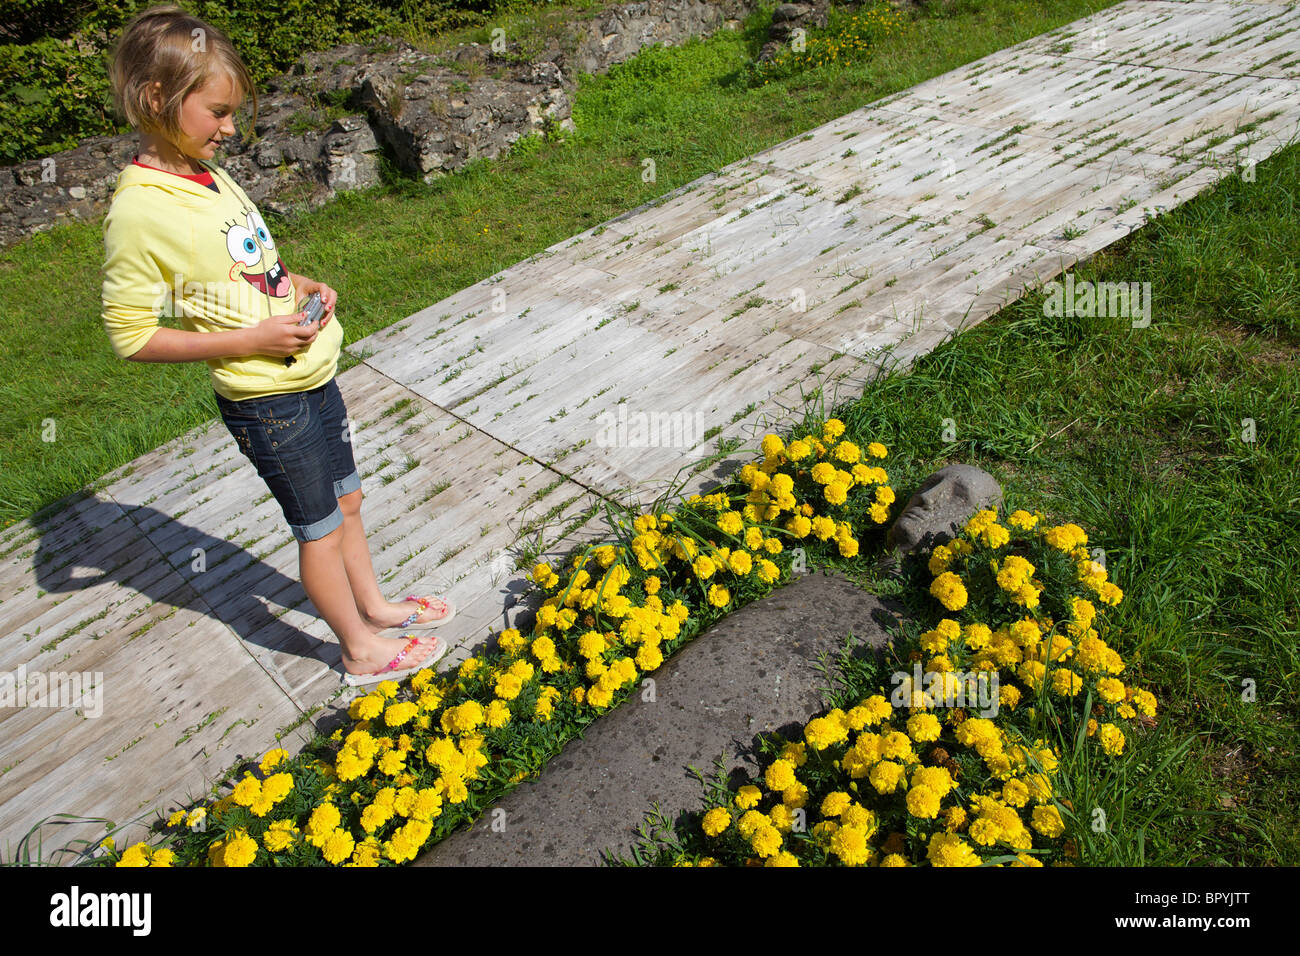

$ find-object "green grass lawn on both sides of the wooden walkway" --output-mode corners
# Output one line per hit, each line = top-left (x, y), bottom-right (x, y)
(0, 0), (1300, 864)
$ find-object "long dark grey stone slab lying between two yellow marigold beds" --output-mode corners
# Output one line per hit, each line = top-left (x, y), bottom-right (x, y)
(416, 572), (902, 866)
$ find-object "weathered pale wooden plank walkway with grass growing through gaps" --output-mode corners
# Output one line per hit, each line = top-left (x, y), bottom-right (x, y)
(0, 0), (1300, 852)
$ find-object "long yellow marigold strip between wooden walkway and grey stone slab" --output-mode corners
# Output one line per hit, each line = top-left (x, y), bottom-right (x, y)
(103, 419), (894, 866)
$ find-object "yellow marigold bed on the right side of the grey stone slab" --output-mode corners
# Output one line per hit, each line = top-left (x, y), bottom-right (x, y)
(634, 510), (1156, 866)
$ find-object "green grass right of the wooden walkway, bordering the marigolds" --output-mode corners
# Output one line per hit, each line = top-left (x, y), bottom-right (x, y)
(616, 136), (1300, 866)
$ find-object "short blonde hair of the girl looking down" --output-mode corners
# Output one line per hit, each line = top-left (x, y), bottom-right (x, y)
(108, 4), (257, 143)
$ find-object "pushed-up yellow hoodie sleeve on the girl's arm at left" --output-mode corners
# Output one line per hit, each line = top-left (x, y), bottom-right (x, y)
(101, 195), (166, 359)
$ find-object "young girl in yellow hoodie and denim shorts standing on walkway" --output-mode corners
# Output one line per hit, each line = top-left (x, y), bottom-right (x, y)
(103, 7), (455, 684)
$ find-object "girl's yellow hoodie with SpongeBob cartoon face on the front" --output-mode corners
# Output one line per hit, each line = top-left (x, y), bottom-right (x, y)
(103, 160), (343, 402)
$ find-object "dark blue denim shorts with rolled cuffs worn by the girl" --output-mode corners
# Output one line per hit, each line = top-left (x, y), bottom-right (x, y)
(213, 378), (361, 541)
